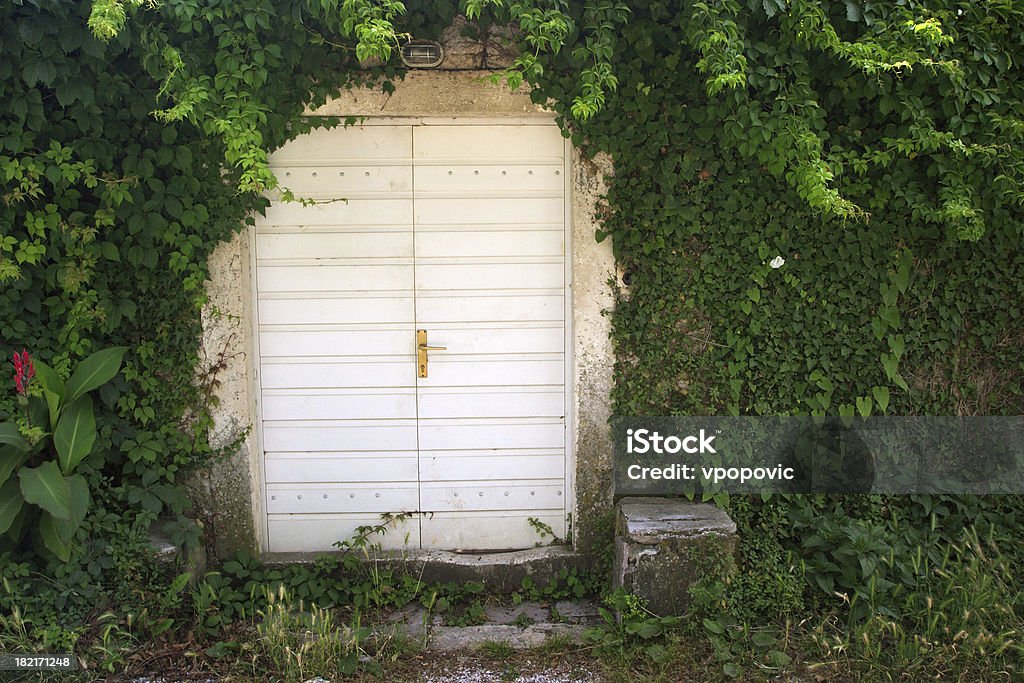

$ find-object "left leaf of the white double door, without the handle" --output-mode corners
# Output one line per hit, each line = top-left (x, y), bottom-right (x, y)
(256, 126), (420, 552)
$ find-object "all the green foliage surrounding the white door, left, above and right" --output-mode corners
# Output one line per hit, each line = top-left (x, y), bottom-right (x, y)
(0, 0), (1024, 675)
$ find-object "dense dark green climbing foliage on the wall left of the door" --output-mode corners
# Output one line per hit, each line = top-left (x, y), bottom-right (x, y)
(0, 1), (387, 647)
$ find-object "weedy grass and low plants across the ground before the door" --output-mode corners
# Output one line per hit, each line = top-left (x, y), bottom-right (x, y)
(0, 520), (1024, 683)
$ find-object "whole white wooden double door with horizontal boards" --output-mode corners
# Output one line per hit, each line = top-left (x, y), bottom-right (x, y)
(255, 121), (567, 551)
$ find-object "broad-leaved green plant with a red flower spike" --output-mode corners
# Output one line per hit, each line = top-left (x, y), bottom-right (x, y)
(0, 347), (127, 562)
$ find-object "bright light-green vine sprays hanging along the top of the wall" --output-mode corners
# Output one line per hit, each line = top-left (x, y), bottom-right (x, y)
(83, 0), (1024, 241)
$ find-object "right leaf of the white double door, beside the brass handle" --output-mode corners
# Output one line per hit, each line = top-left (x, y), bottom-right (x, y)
(413, 125), (566, 550)
